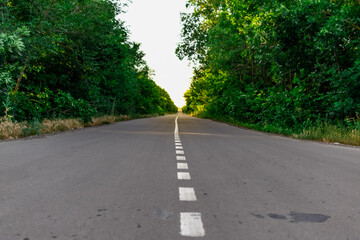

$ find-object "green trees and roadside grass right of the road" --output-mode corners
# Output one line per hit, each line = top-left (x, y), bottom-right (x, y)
(176, 0), (360, 145)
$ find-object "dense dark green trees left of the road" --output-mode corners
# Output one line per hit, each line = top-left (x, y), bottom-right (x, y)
(0, 0), (177, 121)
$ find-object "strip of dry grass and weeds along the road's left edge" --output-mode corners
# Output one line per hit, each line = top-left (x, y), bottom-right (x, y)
(0, 114), (159, 140)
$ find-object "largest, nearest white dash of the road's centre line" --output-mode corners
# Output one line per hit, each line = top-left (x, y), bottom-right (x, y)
(180, 212), (205, 237)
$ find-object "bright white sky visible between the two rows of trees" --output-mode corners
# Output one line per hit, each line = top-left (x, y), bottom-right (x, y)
(120, 0), (192, 107)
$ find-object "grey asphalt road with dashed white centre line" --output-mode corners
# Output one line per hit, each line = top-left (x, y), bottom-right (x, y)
(0, 114), (360, 240)
